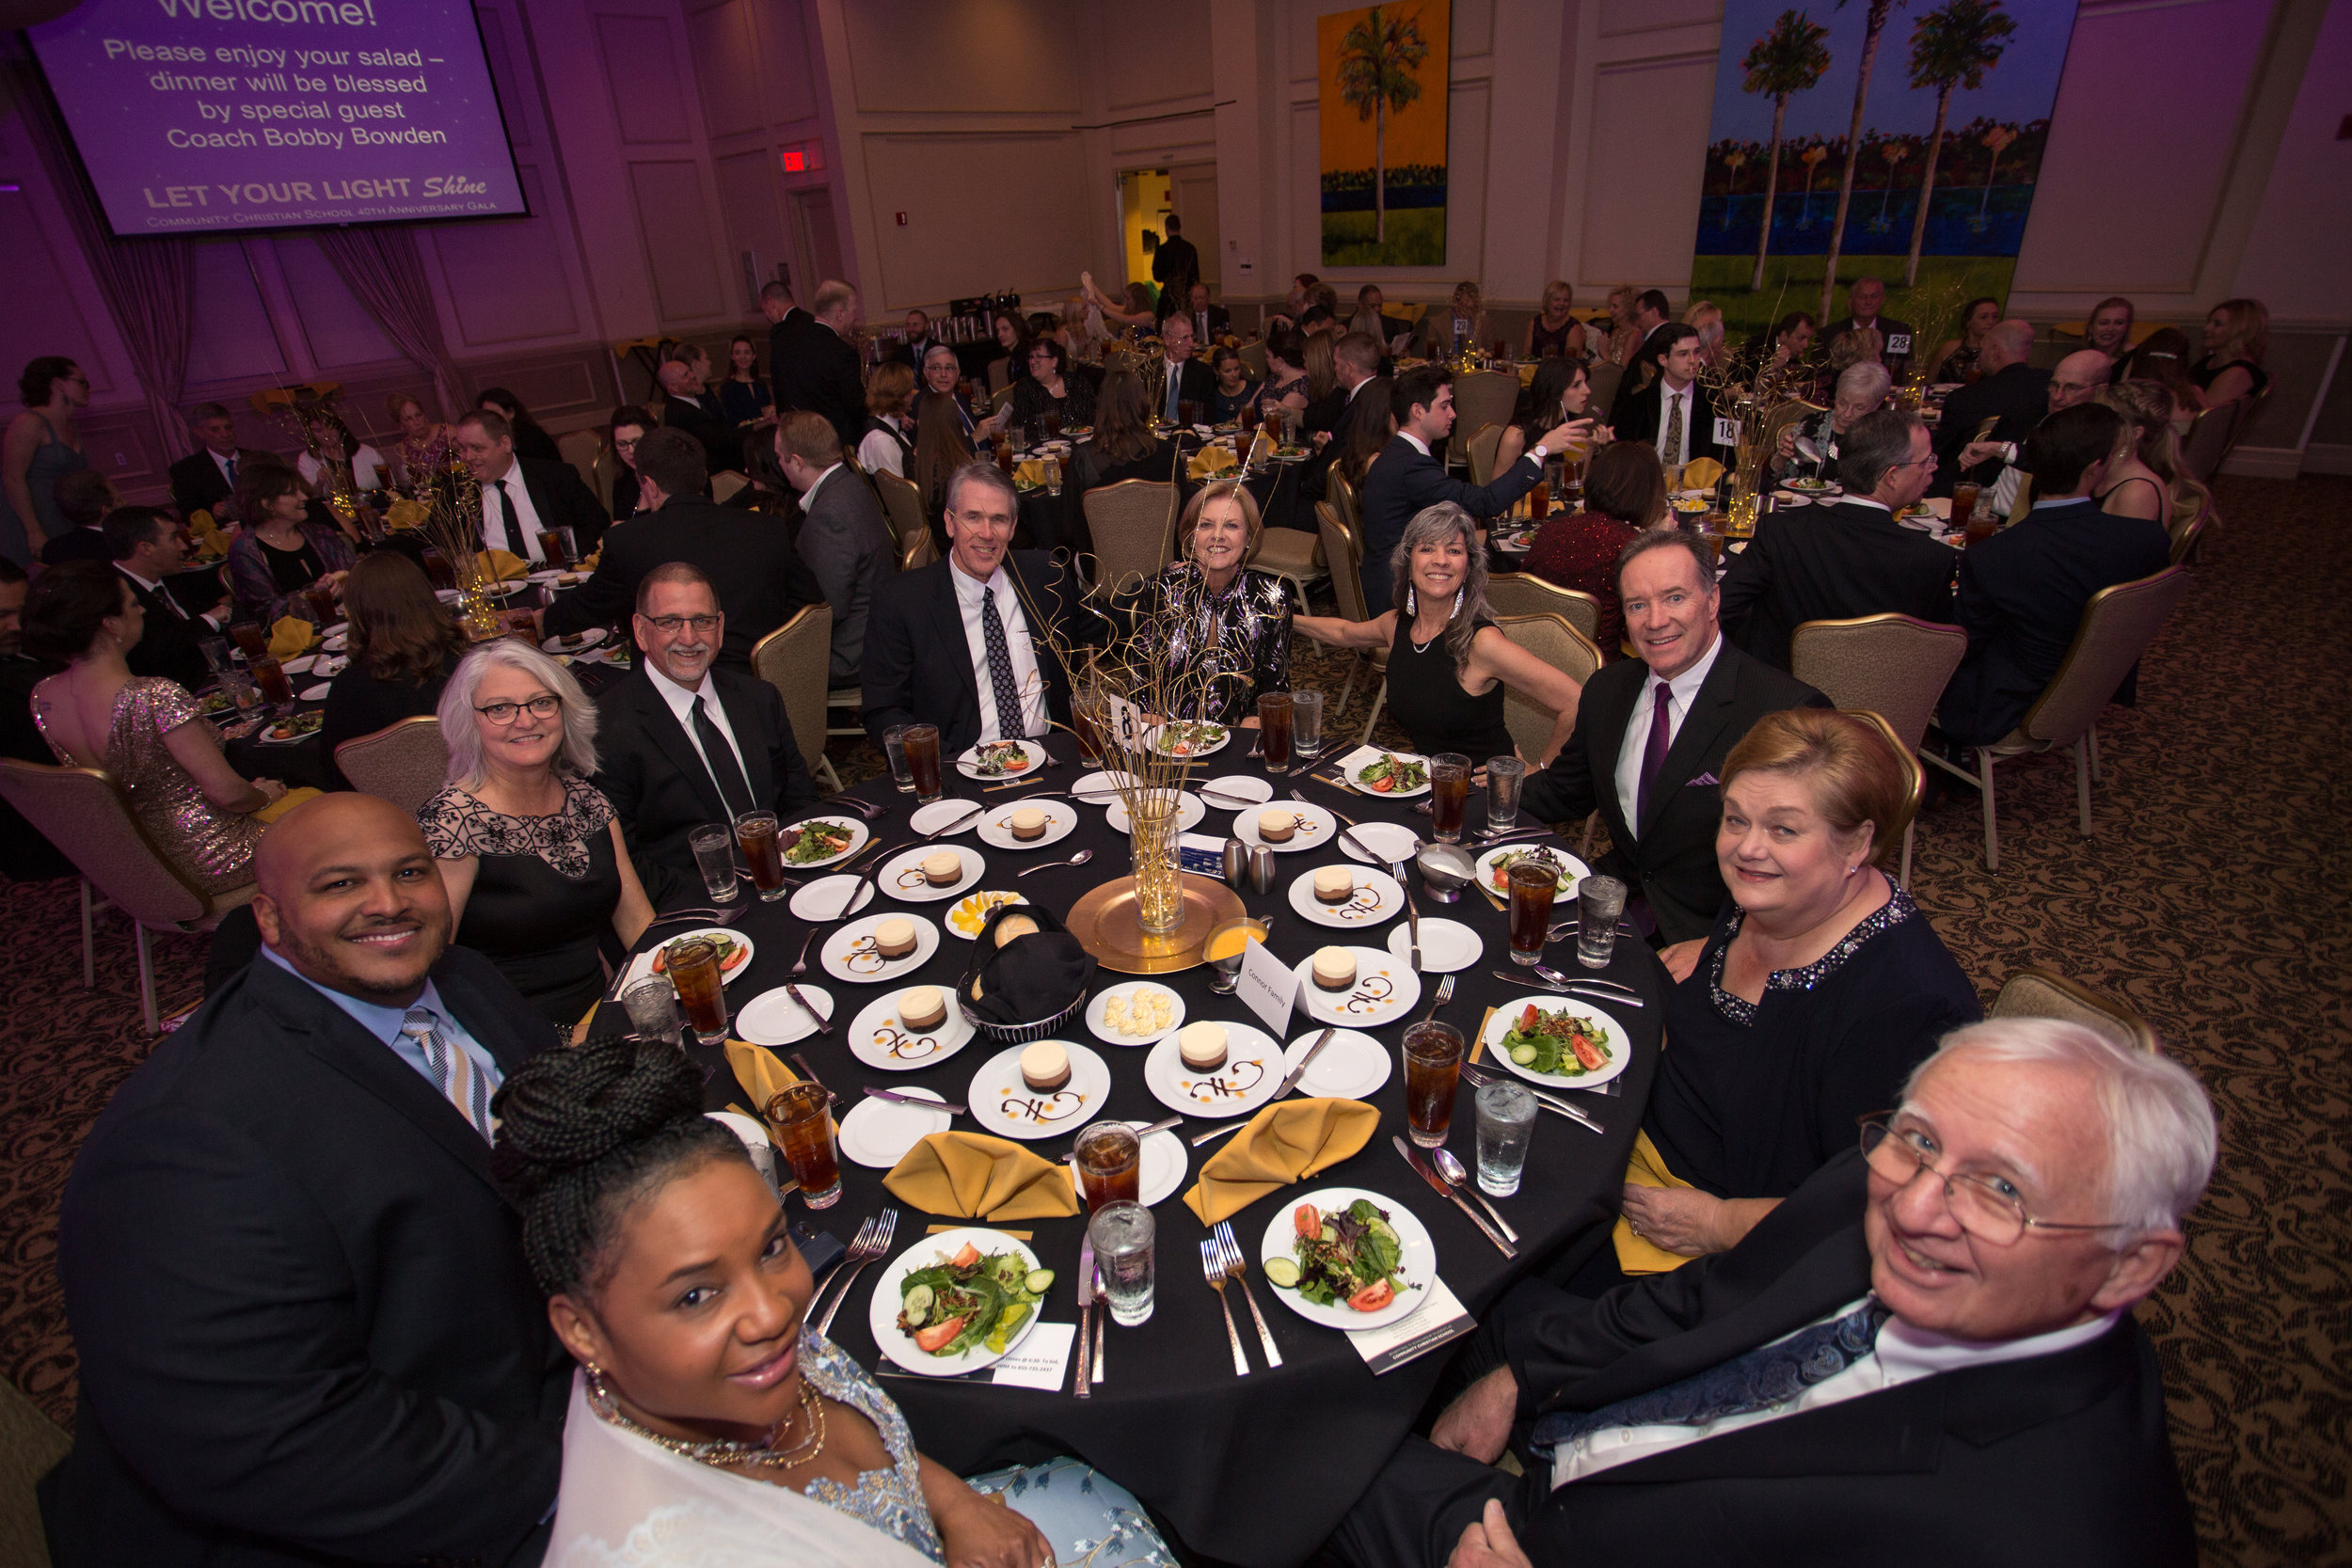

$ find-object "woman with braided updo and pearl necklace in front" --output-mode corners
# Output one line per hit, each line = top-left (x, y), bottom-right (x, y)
(492, 1039), (1174, 1568)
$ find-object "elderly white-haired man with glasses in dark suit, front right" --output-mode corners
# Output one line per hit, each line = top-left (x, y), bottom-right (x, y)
(1327, 1018), (2216, 1568)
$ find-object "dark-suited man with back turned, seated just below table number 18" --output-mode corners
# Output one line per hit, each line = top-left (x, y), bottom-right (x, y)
(1722, 409), (1962, 670)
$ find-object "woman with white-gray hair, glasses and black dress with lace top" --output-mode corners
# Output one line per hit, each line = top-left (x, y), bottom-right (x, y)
(417, 637), (654, 1030)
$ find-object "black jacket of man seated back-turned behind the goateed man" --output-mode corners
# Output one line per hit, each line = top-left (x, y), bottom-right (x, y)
(544, 496), (793, 674)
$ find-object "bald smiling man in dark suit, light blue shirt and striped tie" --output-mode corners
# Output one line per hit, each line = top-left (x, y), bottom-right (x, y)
(40, 795), (572, 1568)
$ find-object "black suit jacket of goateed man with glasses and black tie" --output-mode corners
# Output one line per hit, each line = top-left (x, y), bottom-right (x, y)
(596, 663), (823, 886)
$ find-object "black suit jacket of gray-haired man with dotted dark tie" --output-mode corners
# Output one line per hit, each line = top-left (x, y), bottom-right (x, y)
(866, 550), (1101, 757)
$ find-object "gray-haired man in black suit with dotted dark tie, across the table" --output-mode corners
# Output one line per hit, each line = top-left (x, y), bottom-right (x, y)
(866, 463), (1101, 757)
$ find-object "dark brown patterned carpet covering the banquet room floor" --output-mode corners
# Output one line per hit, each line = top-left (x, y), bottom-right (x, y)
(0, 477), (2352, 1566)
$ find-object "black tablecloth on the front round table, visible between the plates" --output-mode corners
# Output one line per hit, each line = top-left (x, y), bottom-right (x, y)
(596, 731), (1665, 1568)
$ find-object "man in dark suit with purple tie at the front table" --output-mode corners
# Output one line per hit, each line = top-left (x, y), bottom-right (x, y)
(1522, 529), (1830, 945)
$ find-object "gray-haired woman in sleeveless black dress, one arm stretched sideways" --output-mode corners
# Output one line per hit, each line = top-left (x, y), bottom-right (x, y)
(1292, 500), (1583, 767)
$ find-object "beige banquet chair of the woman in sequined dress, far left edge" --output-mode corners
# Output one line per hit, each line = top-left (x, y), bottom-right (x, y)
(0, 757), (254, 1035)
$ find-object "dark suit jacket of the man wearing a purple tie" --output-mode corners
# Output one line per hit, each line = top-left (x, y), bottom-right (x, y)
(1524, 640), (1833, 942)
